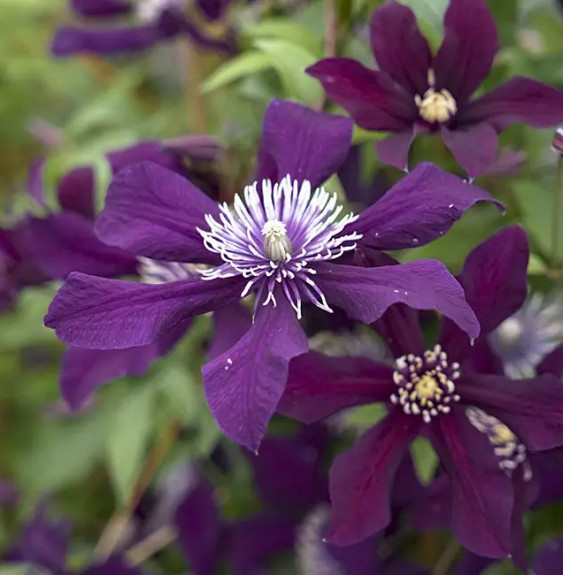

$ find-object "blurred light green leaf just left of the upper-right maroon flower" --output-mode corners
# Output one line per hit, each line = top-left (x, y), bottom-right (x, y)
(256, 39), (323, 106)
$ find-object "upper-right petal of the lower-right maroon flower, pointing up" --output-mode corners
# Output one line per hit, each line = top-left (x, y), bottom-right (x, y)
(439, 226), (529, 359)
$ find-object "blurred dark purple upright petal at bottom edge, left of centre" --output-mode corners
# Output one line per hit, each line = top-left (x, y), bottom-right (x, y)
(174, 480), (223, 575)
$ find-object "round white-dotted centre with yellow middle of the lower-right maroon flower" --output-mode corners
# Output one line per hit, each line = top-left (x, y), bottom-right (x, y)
(391, 345), (460, 423)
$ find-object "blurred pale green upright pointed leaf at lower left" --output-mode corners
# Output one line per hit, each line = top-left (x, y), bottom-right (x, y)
(106, 388), (155, 504)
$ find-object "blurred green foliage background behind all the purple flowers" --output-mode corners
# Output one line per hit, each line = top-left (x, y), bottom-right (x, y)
(0, 0), (563, 575)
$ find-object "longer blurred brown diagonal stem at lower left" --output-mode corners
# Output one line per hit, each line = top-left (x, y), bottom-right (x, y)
(94, 421), (181, 559)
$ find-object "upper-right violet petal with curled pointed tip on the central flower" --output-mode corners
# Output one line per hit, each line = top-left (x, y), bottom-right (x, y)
(343, 162), (502, 250)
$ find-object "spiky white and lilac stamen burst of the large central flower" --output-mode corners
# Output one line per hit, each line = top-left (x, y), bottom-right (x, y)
(198, 176), (362, 317)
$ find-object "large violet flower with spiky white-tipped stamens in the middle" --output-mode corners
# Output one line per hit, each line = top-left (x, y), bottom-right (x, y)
(45, 100), (498, 450)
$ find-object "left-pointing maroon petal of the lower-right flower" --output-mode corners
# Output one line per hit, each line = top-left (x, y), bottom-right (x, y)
(278, 351), (395, 423)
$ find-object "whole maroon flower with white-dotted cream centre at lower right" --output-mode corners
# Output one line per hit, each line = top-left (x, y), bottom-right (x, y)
(279, 227), (563, 558)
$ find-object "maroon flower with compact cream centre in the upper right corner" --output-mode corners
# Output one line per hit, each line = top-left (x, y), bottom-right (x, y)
(308, 0), (563, 177)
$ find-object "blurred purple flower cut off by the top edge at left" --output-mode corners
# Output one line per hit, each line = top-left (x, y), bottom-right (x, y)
(51, 0), (236, 56)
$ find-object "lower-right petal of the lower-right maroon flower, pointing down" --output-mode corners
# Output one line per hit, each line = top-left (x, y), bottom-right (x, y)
(431, 410), (514, 557)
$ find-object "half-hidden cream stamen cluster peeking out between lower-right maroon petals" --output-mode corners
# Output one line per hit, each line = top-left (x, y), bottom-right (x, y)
(466, 407), (532, 481)
